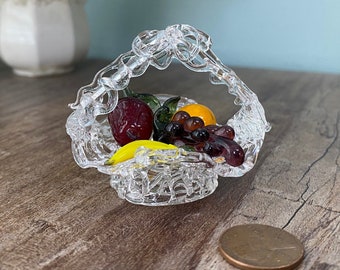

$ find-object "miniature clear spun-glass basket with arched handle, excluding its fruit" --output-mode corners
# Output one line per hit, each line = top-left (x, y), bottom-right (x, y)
(66, 24), (270, 206)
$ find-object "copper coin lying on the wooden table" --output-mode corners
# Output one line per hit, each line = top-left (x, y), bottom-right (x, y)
(219, 224), (304, 270)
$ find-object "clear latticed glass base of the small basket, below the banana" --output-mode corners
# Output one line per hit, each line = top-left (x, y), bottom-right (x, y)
(110, 159), (218, 206)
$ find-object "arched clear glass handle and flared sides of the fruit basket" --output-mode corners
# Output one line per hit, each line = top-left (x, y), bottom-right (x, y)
(66, 24), (270, 177)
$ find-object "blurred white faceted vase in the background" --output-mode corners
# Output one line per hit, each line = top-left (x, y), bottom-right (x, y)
(0, 0), (89, 77)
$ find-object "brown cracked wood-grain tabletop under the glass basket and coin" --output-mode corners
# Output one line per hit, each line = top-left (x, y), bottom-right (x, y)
(0, 61), (340, 269)
